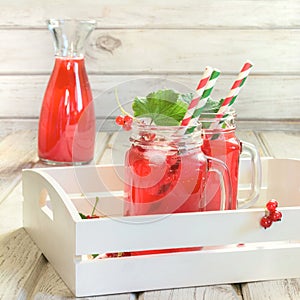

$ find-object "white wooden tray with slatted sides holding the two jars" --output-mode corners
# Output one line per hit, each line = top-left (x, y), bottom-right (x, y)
(23, 158), (300, 296)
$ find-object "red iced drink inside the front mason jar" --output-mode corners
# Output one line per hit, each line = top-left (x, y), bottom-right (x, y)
(125, 146), (207, 255)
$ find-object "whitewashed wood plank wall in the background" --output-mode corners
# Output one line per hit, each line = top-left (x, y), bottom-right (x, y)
(0, 0), (300, 129)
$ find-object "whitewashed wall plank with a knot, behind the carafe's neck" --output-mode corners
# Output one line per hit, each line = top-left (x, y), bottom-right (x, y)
(0, 29), (300, 74)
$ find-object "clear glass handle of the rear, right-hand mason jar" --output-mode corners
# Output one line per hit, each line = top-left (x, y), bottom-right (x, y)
(237, 141), (262, 209)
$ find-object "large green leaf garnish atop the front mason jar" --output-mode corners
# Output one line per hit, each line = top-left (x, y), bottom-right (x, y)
(132, 90), (189, 126)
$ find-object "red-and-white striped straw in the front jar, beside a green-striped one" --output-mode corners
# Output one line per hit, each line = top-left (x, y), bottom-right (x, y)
(180, 66), (213, 126)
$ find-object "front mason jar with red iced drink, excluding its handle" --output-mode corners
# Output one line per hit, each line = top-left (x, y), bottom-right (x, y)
(125, 126), (208, 255)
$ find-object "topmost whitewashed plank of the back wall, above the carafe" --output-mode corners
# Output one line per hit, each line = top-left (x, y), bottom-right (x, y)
(0, 0), (300, 28)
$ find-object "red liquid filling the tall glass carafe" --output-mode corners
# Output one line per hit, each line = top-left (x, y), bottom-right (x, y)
(38, 57), (95, 163)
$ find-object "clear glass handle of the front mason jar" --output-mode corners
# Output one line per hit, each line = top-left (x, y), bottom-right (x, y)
(205, 155), (232, 210)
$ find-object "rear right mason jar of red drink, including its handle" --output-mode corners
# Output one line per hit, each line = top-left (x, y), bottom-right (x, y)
(199, 109), (261, 210)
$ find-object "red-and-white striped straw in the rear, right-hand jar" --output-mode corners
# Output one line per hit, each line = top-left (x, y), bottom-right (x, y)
(218, 61), (253, 117)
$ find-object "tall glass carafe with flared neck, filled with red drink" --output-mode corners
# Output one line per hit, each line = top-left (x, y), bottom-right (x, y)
(38, 19), (96, 164)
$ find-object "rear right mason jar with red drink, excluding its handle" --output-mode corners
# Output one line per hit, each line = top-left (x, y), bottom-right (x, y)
(200, 112), (242, 211)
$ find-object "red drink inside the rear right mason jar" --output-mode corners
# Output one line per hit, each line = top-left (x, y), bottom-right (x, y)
(201, 130), (241, 211)
